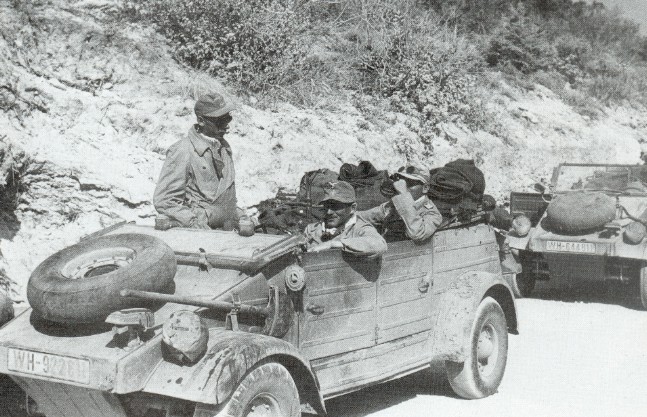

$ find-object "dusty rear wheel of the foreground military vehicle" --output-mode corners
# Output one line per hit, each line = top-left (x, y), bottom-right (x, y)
(445, 297), (508, 399)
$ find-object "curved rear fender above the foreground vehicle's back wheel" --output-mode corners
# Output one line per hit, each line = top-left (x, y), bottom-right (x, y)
(432, 271), (517, 362)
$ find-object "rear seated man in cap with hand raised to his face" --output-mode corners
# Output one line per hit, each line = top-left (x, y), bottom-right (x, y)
(357, 166), (443, 242)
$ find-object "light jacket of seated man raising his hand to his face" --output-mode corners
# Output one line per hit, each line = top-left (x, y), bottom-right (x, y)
(357, 193), (443, 242)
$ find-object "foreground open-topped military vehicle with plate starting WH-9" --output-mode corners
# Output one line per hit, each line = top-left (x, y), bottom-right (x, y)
(0, 216), (517, 417)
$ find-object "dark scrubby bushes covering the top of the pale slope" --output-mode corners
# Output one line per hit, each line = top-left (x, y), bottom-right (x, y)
(127, 0), (647, 125)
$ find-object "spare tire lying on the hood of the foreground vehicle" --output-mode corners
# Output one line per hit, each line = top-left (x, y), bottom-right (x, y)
(27, 233), (177, 324)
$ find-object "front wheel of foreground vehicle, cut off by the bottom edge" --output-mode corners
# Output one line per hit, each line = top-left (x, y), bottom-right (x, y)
(216, 363), (301, 417)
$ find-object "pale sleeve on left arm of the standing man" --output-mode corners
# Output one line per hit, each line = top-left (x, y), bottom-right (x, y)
(153, 144), (197, 227)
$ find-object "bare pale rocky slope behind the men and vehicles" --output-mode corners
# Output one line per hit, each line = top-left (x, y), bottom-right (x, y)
(0, 0), (647, 301)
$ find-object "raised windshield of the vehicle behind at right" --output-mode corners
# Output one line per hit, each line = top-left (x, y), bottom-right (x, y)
(553, 164), (647, 195)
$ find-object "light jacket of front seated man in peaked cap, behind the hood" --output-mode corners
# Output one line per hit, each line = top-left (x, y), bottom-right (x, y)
(303, 216), (387, 258)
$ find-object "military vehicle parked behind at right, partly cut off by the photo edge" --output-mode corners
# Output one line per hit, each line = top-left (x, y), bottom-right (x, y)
(507, 163), (647, 309)
